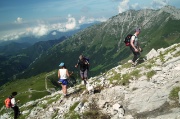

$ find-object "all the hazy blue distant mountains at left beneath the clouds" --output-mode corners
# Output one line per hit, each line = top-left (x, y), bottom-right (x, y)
(0, 22), (98, 85)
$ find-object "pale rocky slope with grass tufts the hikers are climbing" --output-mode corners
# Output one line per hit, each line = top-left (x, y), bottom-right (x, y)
(0, 44), (180, 119)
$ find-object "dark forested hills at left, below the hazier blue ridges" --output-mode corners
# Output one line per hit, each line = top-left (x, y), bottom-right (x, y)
(0, 37), (67, 84)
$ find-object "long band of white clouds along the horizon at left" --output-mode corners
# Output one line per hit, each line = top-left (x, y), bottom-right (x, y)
(0, 15), (107, 41)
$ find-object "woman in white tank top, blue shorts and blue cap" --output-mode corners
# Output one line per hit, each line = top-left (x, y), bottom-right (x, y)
(58, 62), (70, 96)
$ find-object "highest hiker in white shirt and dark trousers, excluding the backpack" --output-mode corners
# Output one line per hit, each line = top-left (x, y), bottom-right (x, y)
(130, 28), (142, 66)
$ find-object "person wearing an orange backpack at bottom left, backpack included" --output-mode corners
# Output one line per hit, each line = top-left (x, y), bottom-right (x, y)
(5, 92), (21, 119)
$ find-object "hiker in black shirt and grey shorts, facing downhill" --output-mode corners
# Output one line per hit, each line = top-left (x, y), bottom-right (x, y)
(75, 55), (89, 85)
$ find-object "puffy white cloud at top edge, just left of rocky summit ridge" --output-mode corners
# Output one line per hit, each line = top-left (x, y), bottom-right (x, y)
(118, 0), (129, 13)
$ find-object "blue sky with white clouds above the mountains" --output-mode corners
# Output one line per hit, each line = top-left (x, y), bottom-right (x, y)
(0, 0), (180, 41)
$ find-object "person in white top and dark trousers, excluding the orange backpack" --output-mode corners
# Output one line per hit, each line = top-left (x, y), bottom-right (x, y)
(10, 92), (20, 119)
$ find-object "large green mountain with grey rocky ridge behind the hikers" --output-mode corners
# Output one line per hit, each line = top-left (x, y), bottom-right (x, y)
(0, 6), (180, 85)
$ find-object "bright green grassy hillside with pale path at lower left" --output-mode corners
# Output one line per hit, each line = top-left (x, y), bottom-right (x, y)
(0, 73), (57, 110)
